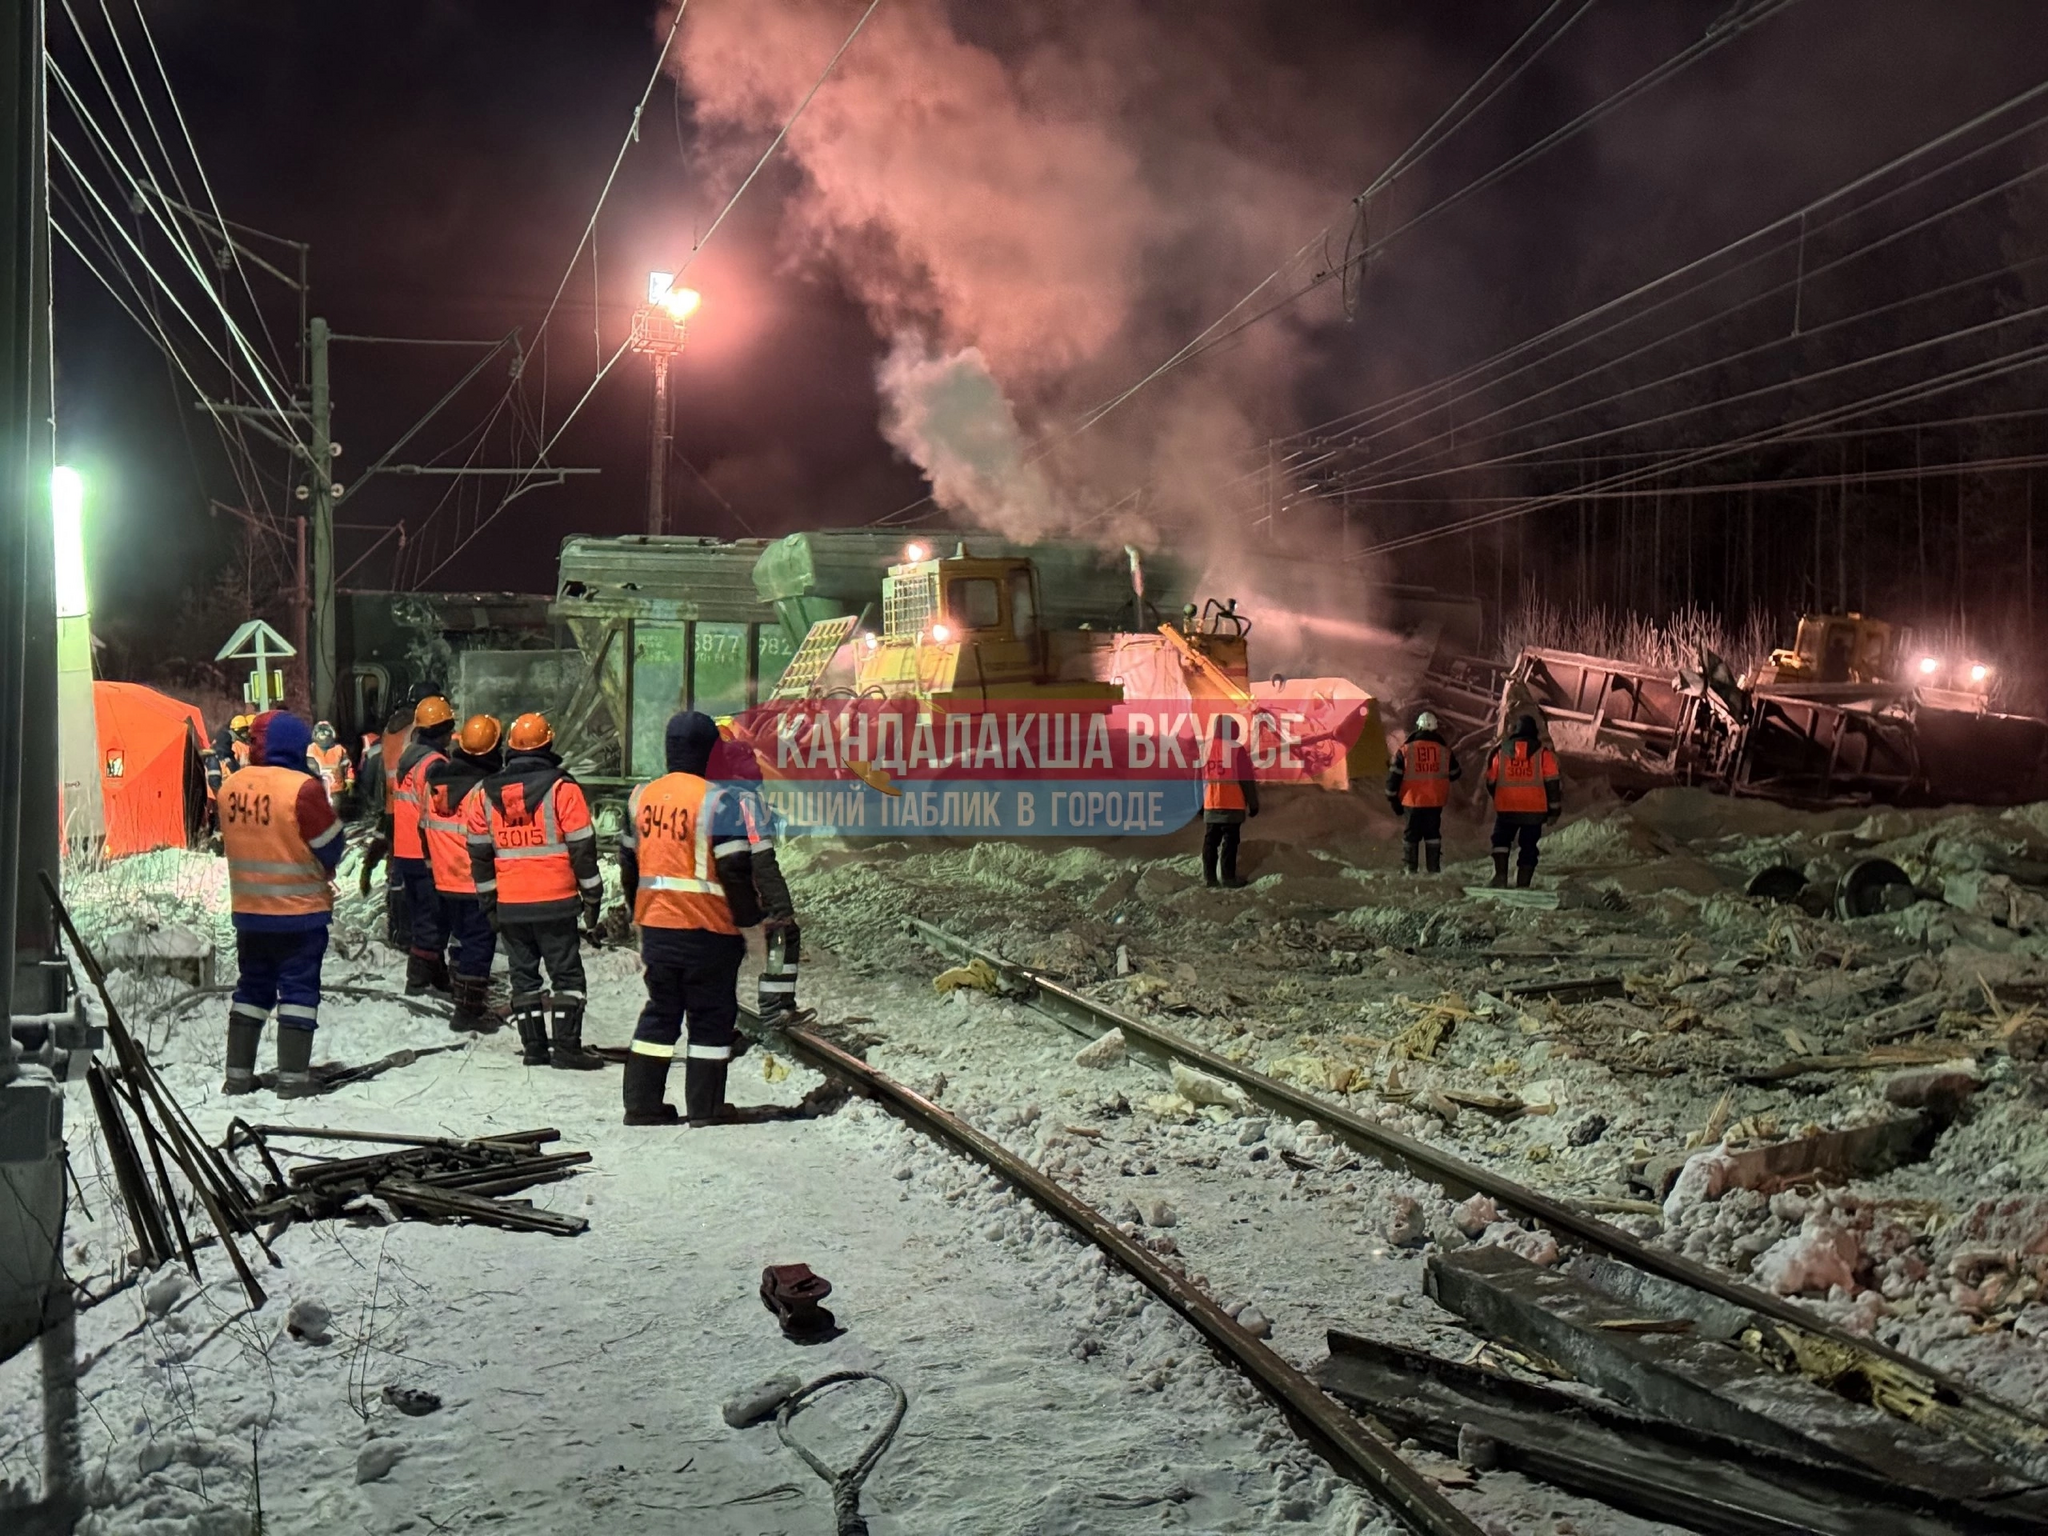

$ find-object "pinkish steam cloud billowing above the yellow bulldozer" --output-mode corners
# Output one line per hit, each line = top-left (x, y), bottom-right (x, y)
(659, 0), (1378, 671)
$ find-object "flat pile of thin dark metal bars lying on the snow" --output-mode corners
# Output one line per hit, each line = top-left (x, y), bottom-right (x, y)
(225, 1120), (590, 1237)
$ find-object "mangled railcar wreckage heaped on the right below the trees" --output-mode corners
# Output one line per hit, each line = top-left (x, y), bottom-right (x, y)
(1421, 647), (2048, 805)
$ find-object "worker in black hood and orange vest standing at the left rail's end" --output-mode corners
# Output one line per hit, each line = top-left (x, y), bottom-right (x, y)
(618, 711), (797, 1126)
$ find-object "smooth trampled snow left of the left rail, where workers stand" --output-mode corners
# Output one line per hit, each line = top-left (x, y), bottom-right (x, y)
(0, 860), (1409, 1536)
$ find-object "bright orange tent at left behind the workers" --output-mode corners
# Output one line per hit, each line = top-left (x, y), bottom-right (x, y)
(92, 682), (207, 858)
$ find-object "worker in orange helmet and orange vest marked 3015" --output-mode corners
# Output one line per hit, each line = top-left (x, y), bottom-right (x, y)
(467, 715), (604, 1071)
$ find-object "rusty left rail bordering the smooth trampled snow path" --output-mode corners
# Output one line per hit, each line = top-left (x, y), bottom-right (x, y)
(765, 1010), (1481, 1536)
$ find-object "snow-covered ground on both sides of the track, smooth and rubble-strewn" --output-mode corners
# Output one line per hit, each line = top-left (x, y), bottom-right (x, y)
(16, 795), (2048, 1536)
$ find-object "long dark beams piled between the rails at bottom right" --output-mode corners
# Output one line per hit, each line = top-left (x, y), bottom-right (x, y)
(1311, 1247), (2048, 1536)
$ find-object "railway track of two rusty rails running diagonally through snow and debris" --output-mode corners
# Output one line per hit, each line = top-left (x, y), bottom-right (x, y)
(752, 920), (2048, 1536)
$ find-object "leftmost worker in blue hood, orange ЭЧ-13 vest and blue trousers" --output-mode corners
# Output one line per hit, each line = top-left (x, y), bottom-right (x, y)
(221, 711), (346, 1098)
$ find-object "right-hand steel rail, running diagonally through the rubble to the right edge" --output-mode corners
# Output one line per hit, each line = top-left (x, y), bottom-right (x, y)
(909, 918), (2048, 1477)
